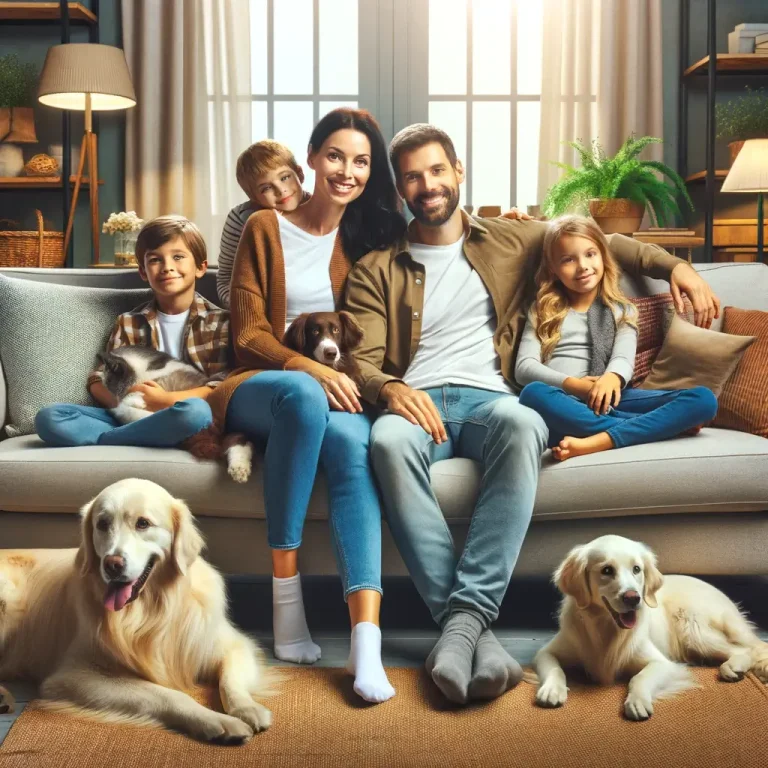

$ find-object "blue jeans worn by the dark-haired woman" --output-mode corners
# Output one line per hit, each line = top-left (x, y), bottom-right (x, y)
(227, 371), (381, 597)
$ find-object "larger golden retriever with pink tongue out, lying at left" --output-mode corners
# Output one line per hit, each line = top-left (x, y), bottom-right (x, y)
(0, 479), (271, 744)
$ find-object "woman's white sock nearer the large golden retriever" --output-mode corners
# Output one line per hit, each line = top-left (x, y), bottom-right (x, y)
(272, 573), (320, 664)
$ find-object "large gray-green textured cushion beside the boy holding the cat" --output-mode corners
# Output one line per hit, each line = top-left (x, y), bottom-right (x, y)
(0, 275), (149, 436)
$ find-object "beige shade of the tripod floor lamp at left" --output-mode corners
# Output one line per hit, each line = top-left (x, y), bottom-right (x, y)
(37, 43), (136, 112)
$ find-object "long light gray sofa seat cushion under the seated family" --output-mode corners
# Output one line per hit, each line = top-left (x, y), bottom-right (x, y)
(0, 429), (768, 522)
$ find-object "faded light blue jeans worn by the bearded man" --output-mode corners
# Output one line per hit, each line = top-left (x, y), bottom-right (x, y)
(371, 386), (547, 626)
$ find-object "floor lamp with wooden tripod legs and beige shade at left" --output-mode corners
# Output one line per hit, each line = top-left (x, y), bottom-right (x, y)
(37, 43), (136, 264)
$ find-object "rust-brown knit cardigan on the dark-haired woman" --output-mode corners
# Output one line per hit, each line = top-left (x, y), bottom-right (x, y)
(208, 210), (352, 427)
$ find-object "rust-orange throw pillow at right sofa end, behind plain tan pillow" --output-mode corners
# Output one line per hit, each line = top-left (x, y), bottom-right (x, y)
(712, 307), (768, 437)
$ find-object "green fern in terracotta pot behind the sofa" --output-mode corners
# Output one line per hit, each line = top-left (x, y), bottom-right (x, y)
(543, 136), (693, 235)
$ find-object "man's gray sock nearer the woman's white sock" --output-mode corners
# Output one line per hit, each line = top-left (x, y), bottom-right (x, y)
(426, 611), (483, 704)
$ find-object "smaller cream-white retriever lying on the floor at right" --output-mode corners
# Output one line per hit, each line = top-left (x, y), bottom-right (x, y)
(533, 536), (768, 720)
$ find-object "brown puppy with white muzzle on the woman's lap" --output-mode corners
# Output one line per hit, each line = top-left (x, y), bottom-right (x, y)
(283, 312), (363, 382)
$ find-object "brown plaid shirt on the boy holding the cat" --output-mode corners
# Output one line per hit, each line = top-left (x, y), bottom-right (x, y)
(88, 293), (230, 387)
